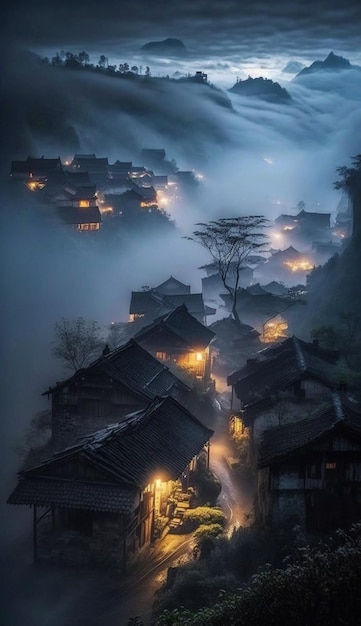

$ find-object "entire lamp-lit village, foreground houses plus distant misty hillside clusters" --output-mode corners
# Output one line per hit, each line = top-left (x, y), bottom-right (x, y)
(8, 149), (361, 620)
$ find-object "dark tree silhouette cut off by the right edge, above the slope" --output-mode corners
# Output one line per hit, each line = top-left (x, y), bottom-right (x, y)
(334, 154), (361, 239)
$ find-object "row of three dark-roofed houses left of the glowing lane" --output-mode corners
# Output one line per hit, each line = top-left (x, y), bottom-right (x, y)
(8, 292), (214, 568)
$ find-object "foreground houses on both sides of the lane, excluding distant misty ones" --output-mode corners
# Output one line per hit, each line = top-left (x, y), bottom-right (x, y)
(8, 266), (361, 568)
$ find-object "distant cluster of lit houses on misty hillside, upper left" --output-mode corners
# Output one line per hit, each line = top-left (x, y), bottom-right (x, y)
(10, 149), (197, 231)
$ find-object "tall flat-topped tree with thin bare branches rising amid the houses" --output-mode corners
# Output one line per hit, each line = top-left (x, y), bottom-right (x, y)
(186, 215), (268, 324)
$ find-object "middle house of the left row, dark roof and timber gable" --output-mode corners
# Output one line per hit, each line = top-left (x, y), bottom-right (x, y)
(43, 339), (191, 448)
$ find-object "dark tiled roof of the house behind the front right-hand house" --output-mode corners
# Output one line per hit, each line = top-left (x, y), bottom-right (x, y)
(227, 336), (337, 403)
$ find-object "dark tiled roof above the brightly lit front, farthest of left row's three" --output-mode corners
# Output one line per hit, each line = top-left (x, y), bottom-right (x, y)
(135, 304), (215, 348)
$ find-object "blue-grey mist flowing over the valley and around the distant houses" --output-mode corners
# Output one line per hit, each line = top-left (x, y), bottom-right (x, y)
(0, 30), (361, 624)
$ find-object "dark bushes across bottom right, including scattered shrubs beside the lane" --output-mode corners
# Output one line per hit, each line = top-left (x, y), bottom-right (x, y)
(155, 524), (361, 626)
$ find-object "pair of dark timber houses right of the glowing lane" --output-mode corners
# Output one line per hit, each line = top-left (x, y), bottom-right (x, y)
(227, 336), (361, 533)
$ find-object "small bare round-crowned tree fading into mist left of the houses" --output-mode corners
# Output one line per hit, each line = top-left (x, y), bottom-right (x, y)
(52, 317), (103, 371)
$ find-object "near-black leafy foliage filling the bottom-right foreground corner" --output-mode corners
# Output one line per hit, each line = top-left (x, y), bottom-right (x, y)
(155, 524), (361, 626)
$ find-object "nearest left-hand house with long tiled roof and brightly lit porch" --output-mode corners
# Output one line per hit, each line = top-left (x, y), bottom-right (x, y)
(8, 396), (213, 568)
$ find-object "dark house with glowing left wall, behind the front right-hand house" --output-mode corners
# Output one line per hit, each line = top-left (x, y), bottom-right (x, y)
(227, 336), (340, 444)
